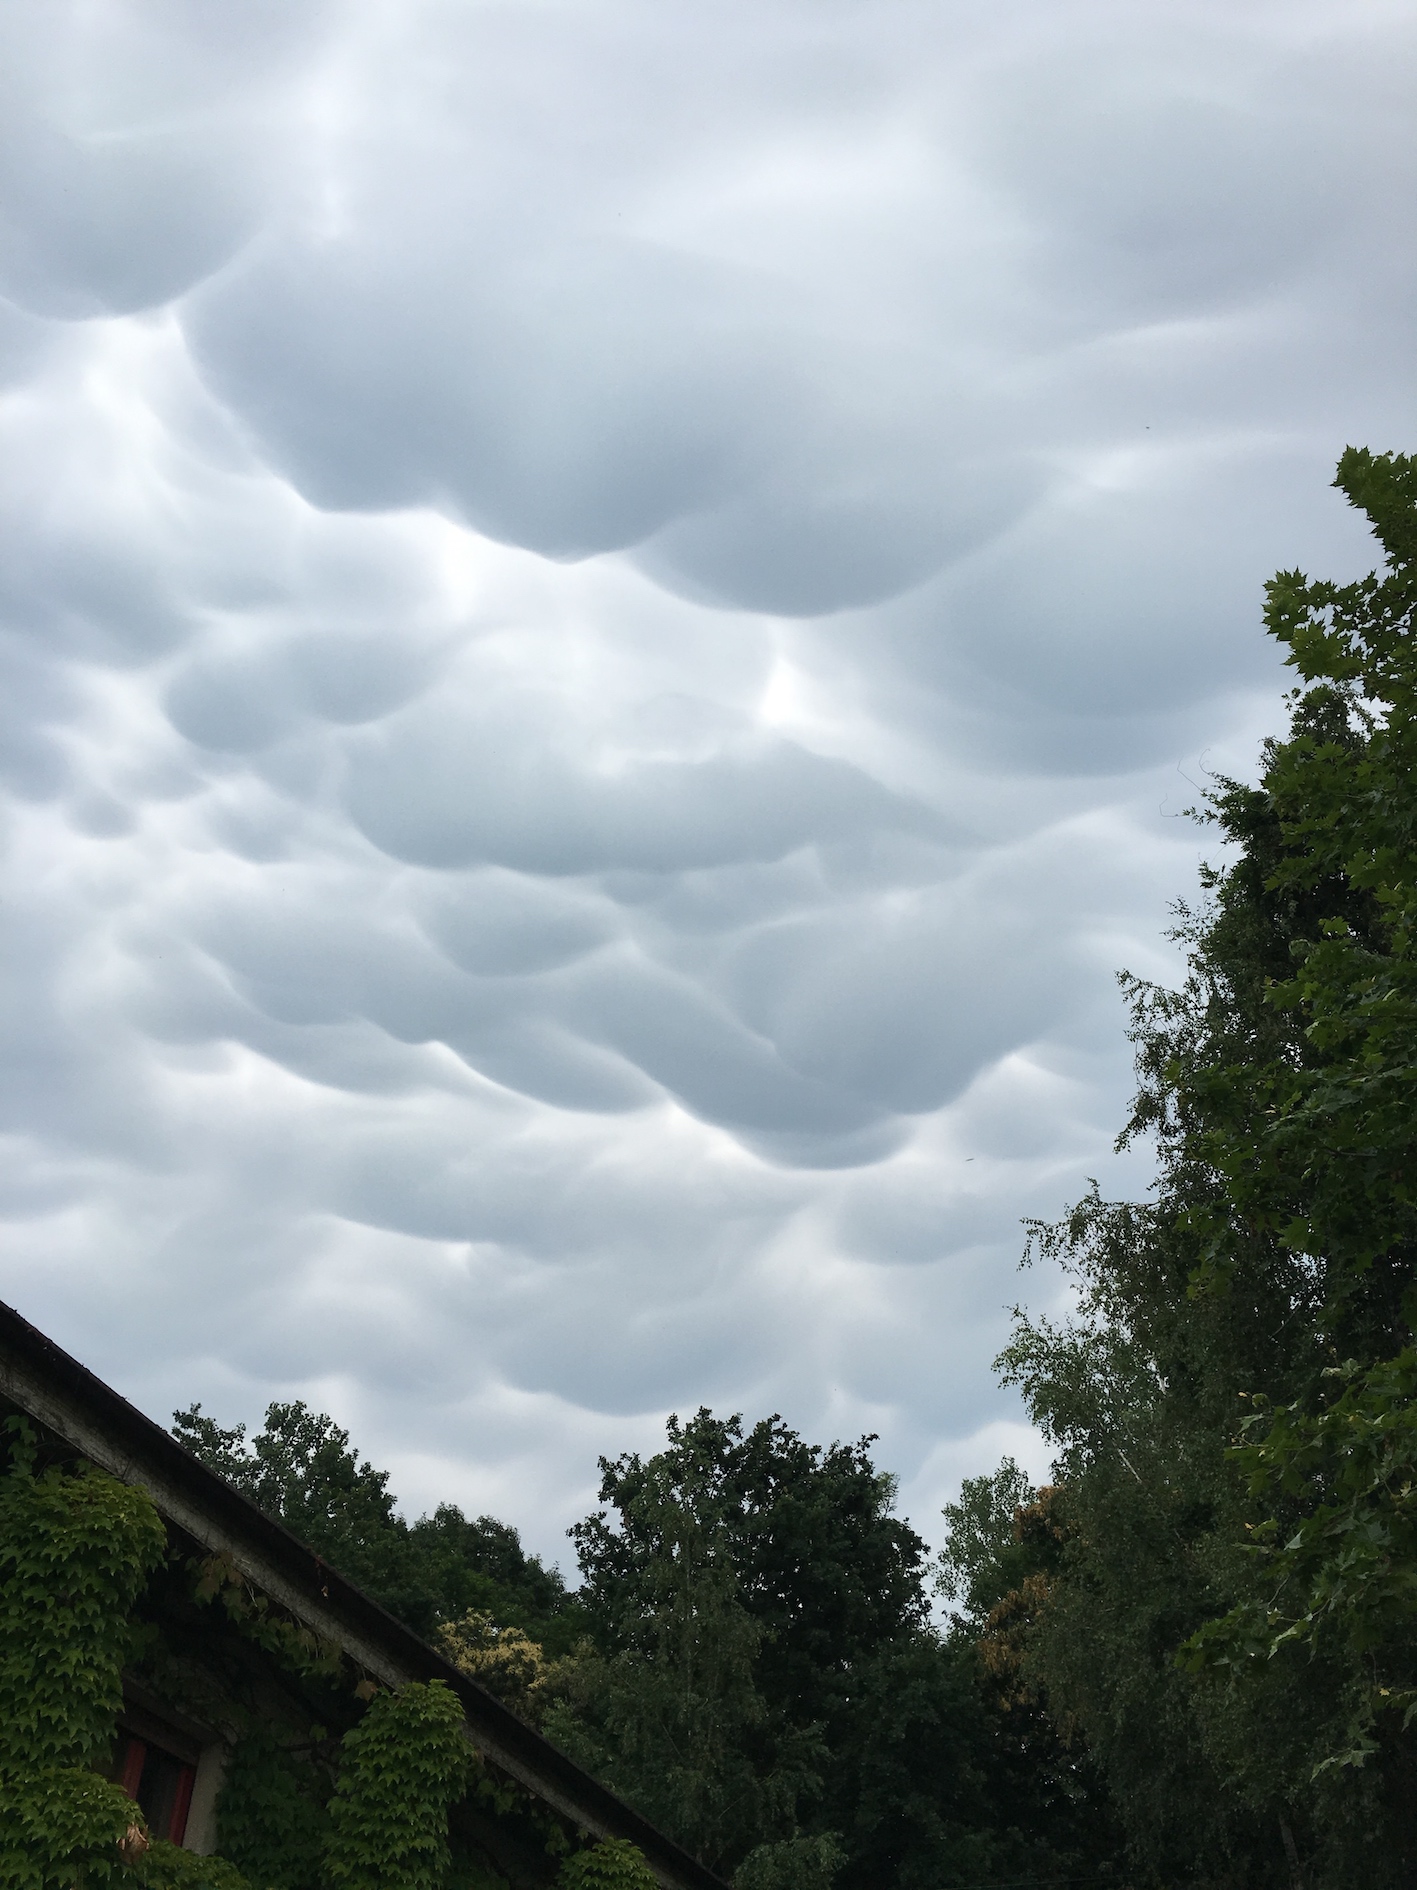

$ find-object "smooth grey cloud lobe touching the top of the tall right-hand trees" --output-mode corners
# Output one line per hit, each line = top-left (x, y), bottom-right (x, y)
(803, 438), (1398, 779)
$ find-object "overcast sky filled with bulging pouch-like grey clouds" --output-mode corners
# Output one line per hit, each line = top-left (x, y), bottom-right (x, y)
(0, 0), (1417, 1563)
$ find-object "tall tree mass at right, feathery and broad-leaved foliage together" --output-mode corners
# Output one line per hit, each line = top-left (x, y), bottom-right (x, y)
(1001, 450), (1417, 1886)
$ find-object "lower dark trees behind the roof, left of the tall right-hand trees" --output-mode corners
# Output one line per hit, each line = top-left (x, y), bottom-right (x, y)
(176, 1404), (1120, 1890)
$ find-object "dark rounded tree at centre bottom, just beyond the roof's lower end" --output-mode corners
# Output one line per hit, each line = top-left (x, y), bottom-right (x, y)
(563, 1410), (1092, 1890)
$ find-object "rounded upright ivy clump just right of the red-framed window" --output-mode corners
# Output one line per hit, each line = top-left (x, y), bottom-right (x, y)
(325, 1680), (470, 1890)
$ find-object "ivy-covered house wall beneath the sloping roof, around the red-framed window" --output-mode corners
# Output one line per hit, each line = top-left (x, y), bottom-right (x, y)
(0, 1406), (656, 1890)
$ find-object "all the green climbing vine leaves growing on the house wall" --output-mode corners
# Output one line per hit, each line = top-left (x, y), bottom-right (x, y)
(0, 1418), (656, 1890)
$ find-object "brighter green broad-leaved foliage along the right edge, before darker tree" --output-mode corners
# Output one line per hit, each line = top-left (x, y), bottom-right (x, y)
(1192, 450), (1417, 1761)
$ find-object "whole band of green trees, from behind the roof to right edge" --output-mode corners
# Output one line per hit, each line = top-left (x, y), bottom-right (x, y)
(178, 450), (1417, 1890)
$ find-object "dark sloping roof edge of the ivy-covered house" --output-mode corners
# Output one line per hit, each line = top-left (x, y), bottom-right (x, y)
(0, 1302), (724, 1890)
